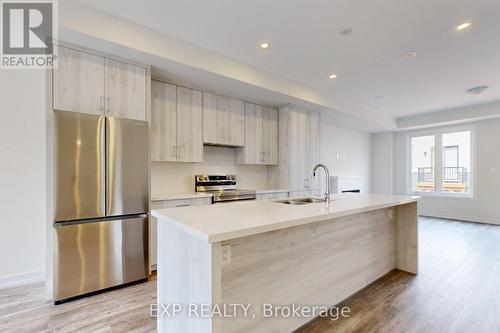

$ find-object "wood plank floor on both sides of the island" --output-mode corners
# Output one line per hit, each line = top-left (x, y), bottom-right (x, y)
(0, 218), (500, 333)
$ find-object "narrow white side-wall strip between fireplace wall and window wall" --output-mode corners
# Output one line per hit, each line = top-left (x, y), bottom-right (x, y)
(371, 132), (394, 194)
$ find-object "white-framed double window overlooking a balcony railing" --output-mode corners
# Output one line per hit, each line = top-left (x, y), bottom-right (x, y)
(408, 130), (472, 196)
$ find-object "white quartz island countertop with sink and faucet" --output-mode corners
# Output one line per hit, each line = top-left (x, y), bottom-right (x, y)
(152, 193), (419, 243)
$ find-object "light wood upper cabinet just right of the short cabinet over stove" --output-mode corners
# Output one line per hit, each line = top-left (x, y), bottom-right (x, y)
(236, 103), (278, 165)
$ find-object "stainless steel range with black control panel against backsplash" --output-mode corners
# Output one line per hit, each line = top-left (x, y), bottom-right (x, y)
(194, 175), (257, 203)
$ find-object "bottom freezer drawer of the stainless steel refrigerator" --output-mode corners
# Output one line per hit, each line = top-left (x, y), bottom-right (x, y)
(54, 215), (149, 301)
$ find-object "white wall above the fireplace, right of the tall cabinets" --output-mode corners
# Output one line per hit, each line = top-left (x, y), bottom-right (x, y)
(320, 117), (371, 192)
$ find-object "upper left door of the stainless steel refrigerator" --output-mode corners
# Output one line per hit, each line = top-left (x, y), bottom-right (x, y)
(54, 111), (105, 221)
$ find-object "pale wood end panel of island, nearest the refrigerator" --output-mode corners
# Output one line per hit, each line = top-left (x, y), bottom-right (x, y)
(157, 221), (222, 333)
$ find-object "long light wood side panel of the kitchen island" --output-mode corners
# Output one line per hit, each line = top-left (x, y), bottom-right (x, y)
(221, 208), (396, 332)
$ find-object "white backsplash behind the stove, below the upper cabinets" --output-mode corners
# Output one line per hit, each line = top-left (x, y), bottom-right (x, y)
(151, 146), (272, 194)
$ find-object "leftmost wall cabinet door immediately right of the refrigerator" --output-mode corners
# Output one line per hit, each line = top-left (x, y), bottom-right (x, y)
(151, 81), (177, 161)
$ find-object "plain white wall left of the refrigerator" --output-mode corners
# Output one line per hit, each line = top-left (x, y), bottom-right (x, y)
(0, 70), (46, 284)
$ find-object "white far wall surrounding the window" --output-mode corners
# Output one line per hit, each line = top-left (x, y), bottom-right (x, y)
(394, 119), (500, 224)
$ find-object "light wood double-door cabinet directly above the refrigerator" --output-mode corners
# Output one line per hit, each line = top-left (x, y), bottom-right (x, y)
(53, 46), (149, 120)
